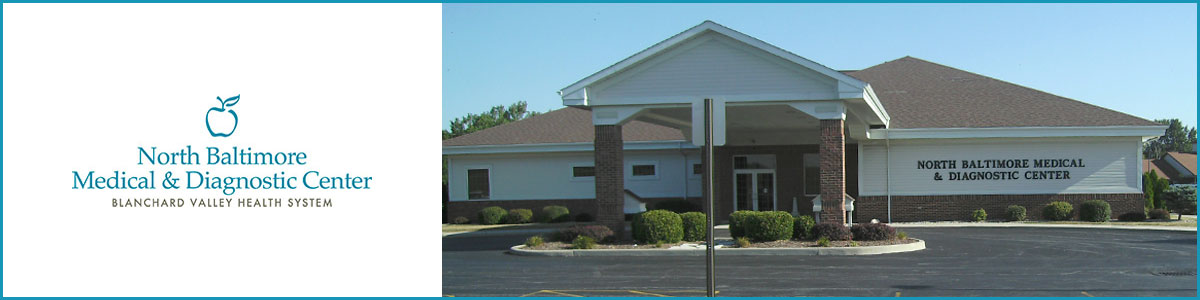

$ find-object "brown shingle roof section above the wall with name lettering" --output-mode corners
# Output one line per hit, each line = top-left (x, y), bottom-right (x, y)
(844, 56), (1157, 128)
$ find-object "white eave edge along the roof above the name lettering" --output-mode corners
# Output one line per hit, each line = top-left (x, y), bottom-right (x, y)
(866, 126), (1166, 140)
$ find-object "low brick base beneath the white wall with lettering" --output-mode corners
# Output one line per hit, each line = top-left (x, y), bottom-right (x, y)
(854, 193), (1145, 222)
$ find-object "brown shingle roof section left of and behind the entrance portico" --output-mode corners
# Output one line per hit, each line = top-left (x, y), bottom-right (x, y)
(442, 107), (684, 146)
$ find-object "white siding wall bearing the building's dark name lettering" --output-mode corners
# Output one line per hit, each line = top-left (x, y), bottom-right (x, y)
(859, 138), (1141, 196)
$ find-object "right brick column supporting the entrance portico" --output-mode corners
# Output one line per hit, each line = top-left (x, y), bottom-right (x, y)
(821, 119), (846, 223)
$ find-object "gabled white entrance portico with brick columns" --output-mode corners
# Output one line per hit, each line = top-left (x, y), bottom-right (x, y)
(559, 22), (889, 232)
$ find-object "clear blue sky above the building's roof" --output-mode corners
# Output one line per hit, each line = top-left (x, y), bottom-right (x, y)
(442, 4), (1196, 128)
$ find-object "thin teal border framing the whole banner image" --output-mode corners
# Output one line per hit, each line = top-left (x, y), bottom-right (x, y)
(0, 0), (1200, 300)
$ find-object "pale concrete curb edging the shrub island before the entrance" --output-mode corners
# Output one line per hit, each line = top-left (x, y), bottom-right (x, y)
(508, 240), (925, 257)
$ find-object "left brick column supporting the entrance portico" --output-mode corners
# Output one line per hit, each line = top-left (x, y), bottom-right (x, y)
(594, 125), (625, 239)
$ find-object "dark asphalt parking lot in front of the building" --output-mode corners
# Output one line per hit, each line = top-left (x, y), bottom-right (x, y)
(442, 228), (1196, 296)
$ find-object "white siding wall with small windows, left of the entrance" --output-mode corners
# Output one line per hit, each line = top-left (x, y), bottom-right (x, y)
(450, 150), (701, 200)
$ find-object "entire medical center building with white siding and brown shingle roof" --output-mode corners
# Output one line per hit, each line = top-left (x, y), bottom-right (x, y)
(443, 22), (1161, 226)
